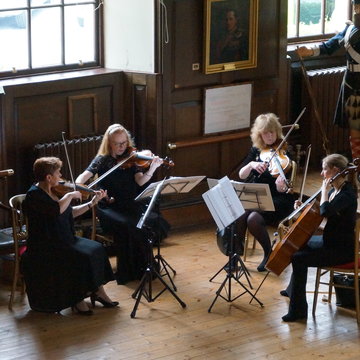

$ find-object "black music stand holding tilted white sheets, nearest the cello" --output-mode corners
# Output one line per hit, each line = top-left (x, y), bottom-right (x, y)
(203, 177), (263, 312)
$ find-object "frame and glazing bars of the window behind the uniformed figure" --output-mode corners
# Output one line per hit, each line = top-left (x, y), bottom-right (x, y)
(287, 0), (353, 46)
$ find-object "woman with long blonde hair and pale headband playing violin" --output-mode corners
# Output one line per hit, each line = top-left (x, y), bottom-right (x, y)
(76, 124), (169, 284)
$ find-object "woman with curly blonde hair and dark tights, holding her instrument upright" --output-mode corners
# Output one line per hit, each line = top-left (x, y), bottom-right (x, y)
(237, 113), (294, 271)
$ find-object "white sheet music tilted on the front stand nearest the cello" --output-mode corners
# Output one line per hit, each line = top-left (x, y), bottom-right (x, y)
(202, 177), (245, 230)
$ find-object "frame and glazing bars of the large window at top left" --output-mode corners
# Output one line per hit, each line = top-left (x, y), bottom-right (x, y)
(0, 0), (104, 80)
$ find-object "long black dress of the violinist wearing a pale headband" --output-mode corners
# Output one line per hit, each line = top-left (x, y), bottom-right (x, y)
(86, 155), (170, 284)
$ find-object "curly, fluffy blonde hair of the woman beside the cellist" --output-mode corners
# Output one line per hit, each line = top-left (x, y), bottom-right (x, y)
(250, 113), (284, 150)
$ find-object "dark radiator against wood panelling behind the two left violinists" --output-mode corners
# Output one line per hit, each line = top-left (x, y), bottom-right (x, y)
(34, 135), (102, 181)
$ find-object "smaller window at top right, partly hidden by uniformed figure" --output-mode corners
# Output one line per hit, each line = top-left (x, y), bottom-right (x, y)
(288, 0), (352, 43)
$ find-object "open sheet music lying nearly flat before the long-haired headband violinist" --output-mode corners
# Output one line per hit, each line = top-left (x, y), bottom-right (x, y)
(135, 176), (205, 200)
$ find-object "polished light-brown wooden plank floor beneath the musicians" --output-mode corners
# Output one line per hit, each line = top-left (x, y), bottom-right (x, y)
(0, 173), (360, 360)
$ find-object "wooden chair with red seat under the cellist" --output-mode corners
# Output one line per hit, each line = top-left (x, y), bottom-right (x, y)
(312, 219), (360, 324)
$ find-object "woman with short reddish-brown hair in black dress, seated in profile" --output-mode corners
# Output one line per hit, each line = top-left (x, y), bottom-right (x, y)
(21, 157), (118, 315)
